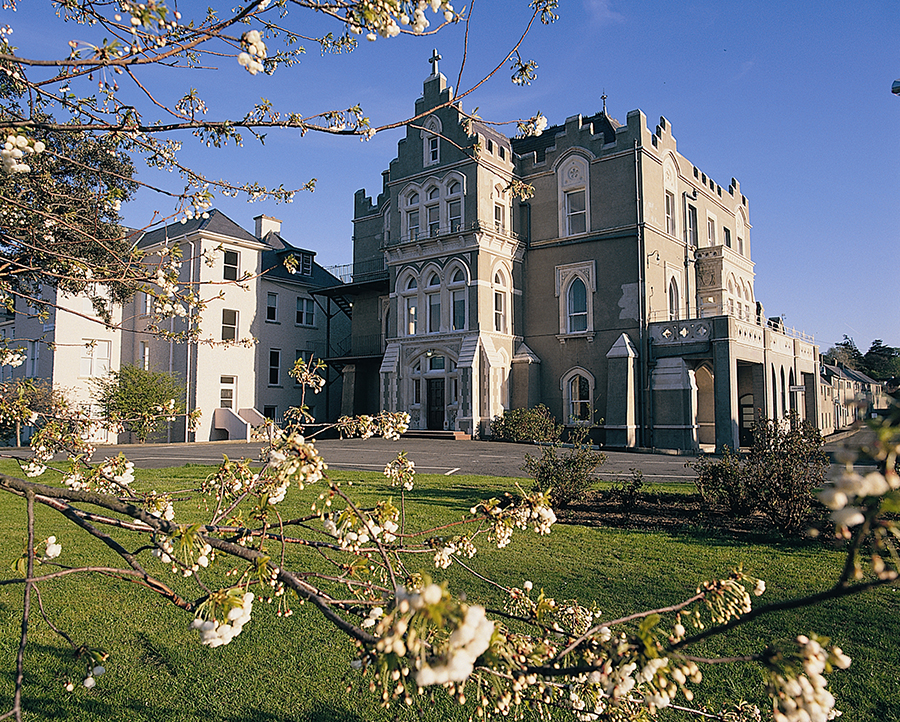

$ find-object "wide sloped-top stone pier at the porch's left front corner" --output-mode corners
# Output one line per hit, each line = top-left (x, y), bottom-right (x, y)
(650, 358), (699, 450)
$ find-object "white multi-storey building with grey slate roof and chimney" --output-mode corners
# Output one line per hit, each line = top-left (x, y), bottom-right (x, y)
(0, 210), (349, 443)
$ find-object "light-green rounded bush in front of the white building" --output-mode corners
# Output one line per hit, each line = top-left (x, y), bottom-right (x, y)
(93, 364), (184, 444)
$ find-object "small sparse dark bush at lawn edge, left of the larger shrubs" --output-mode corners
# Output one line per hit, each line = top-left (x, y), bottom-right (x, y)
(522, 428), (606, 508)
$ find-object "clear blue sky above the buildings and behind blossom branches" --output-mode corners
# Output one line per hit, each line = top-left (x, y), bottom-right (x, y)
(12, 0), (900, 351)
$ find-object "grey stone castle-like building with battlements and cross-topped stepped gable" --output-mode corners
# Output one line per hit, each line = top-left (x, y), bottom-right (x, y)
(328, 54), (820, 449)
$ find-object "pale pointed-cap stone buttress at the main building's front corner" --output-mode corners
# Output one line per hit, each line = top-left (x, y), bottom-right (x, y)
(603, 333), (638, 447)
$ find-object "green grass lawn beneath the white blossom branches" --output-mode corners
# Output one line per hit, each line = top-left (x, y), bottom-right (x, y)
(0, 462), (900, 722)
